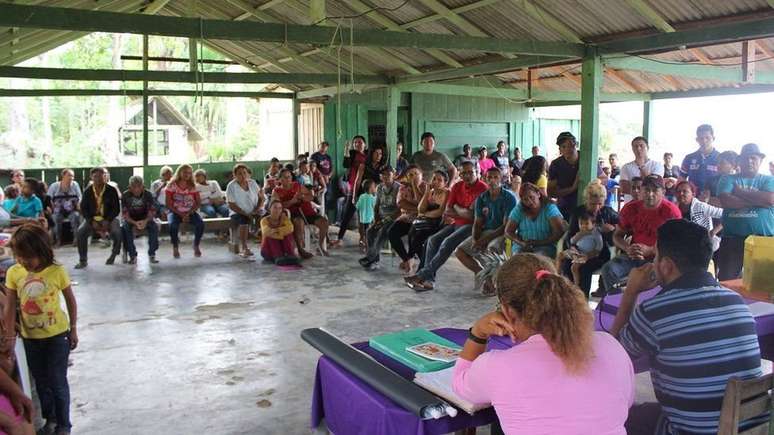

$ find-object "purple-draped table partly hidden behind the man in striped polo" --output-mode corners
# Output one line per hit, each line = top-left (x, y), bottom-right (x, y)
(594, 287), (774, 364)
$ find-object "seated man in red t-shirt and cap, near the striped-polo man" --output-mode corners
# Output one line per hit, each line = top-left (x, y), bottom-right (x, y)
(600, 175), (682, 295)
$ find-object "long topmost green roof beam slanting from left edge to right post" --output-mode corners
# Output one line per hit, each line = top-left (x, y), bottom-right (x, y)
(0, 3), (585, 57)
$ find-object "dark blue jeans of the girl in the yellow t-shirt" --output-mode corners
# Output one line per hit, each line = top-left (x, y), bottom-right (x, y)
(24, 332), (72, 431)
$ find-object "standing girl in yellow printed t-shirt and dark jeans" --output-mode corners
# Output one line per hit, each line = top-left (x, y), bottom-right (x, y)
(5, 225), (78, 435)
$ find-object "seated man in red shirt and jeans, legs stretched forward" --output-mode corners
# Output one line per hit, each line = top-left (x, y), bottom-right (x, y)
(405, 162), (487, 292)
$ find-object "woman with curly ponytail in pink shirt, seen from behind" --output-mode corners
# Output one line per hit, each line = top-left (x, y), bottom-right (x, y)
(454, 254), (634, 435)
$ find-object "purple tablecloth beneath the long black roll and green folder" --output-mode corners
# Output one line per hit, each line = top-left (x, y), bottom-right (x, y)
(311, 328), (513, 435)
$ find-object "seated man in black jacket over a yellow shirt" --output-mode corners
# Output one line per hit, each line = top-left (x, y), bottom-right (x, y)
(75, 167), (121, 269)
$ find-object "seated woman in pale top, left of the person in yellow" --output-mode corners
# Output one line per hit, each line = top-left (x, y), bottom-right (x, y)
(226, 163), (264, 258)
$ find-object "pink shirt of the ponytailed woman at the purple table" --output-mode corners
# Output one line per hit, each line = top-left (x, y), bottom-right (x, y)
(454, 332), (634, 435)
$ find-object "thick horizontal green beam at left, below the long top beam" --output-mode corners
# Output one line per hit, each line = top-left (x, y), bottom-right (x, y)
(0, 66), (389, 84)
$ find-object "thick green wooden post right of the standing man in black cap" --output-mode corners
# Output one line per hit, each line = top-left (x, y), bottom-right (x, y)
(578, 48), (602, 203)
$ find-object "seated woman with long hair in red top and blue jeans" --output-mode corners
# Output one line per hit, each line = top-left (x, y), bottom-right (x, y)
(166, 165), (204, 258)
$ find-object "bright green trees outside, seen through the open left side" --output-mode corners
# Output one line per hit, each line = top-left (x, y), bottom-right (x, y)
(0, 33), (266, 167)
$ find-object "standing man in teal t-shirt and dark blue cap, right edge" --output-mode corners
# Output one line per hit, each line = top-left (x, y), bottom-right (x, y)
(718, 143), (774, 281)
